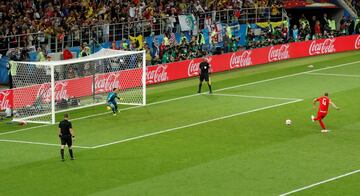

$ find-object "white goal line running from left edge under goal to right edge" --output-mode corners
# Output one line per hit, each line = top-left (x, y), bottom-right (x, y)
(0, 61), (360, 136)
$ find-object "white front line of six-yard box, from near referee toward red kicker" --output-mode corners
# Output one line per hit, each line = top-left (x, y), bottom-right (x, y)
(93, 100), (302, 149)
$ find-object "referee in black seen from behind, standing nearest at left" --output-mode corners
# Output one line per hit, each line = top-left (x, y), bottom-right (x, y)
(59, 113), (75, 161)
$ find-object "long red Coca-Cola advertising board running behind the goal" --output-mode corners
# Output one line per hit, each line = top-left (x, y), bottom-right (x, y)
(0, 35), (360, 110)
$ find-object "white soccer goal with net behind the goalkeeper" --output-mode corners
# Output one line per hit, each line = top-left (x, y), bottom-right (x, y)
(12, 49), (146, 124)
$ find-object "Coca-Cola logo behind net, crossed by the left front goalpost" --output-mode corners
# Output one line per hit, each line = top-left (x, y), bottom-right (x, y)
(36, 81), (69, 102)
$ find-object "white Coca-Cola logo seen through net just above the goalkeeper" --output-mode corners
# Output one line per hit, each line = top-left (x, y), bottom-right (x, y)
(95, 73), (120, 93)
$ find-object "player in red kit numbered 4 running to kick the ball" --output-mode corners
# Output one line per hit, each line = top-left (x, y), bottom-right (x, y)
(311, 93), (339, 133)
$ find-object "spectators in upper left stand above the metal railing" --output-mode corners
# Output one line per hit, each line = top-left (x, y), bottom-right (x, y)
(0, 0), (256, 43)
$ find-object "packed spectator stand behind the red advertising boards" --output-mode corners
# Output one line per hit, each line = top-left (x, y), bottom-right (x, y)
(0, 0), (359, 70)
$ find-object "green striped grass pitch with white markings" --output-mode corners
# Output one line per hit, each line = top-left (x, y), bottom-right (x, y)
(0, 51), (360, 195)
